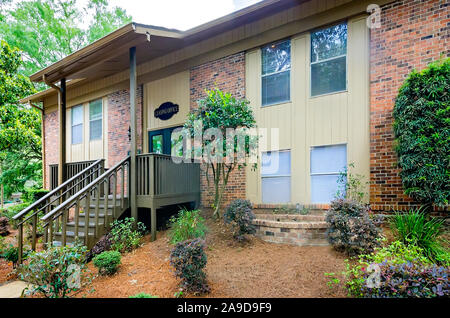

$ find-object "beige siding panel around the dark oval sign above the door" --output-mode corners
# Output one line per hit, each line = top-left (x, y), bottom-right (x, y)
(144, 71), (190, 151)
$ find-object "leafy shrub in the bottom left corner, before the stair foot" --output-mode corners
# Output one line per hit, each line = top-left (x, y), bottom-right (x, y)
(18, 244), (86, 298)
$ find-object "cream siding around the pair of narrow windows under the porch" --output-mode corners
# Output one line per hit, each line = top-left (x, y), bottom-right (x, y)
(66, 98), (108, 166)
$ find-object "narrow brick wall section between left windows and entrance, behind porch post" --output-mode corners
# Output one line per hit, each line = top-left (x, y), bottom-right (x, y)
(108, 85), (143, 167)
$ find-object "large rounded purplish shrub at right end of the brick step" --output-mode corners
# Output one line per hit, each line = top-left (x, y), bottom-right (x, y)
(326, 199), (380, 255)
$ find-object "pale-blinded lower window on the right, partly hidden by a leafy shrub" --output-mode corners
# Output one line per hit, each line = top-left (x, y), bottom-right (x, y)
(311, 145), (347, 203)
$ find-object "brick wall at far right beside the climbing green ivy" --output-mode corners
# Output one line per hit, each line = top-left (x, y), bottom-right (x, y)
(370, 0), (450, 210)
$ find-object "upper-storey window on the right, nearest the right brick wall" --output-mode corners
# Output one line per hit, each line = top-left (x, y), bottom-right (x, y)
(311, 23), (347, 96)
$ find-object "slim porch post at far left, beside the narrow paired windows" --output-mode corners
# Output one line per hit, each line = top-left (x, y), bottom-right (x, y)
(58, 78), (66, 185)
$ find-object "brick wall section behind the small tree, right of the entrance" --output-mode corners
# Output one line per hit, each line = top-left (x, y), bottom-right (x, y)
(190, 53), (245, 207)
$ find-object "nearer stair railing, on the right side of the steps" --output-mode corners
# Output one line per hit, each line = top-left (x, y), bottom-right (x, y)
(41, 157), (130, 251)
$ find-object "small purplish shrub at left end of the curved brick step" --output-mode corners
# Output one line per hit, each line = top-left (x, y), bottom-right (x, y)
(223, 199), (256, 241)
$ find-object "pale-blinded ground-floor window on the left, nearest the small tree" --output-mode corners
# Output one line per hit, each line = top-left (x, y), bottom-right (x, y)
(261, 150), (291, 203)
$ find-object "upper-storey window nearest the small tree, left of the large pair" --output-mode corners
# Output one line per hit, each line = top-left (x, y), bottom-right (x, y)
(262, 40), (291, 106)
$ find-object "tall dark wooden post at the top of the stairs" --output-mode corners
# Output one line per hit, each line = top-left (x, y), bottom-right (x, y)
(129, 47), (138, 222)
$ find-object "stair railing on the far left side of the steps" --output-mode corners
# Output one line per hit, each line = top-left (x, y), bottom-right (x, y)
(13, 159), (105, 264)
